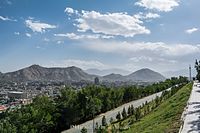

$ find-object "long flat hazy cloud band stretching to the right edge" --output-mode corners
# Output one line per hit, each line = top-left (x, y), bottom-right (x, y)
(84, 41), (200, 57)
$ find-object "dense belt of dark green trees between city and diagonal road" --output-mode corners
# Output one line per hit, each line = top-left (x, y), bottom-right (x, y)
(0, 77), (187, 133)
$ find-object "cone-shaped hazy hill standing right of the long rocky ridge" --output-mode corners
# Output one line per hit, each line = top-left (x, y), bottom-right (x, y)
(125, 68), (165, 82)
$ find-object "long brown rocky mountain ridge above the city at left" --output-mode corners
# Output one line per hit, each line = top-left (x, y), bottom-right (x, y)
(1, 65), (95, 82)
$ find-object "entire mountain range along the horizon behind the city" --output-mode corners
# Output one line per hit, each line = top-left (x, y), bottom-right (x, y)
(0, 65), (165, 82)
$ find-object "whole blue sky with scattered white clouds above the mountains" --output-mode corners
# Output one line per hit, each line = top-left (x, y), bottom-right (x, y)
(0, 0), (200, 76)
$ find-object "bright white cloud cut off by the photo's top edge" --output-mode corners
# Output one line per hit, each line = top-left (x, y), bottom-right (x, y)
(135, 0), (179, 12)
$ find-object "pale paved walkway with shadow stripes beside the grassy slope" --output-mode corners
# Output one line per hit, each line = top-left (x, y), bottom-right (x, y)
(179, 82), (200, 133)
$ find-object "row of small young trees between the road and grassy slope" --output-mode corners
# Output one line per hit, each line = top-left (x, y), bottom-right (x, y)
(90, 84), (184, 133)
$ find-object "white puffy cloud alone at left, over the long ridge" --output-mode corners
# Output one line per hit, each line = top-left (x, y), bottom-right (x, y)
(25, 19), (56, 33)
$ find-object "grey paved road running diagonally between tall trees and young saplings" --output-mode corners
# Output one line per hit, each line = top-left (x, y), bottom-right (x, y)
(62, 88), (171, 133)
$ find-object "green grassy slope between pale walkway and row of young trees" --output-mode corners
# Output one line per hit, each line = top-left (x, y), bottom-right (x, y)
(124, 84), (192, 133)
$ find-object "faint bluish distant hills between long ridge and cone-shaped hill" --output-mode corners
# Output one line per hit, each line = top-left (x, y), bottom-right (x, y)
(85, 68), (131, 76)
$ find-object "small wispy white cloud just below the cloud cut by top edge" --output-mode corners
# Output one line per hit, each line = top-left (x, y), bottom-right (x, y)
(134, 12), (160, 19)
